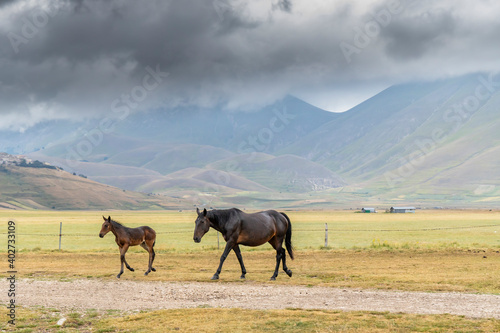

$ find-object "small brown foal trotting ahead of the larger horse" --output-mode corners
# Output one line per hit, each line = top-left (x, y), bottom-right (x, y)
(99, 216), (156, 278)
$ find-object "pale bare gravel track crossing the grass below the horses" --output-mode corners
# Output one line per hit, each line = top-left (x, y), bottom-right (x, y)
(5, 279), (500, 319)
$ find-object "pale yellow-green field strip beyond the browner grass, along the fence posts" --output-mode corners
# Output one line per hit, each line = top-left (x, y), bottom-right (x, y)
(0, 210), (500, 253)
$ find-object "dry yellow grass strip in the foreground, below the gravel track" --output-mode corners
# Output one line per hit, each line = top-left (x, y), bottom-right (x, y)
(0, 308), (500, 333)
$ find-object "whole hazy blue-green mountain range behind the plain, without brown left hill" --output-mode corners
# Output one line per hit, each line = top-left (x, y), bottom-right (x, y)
(0, 73), (500, 208)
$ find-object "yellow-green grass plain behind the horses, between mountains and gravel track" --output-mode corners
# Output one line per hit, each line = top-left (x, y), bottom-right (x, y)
(0, 211), (500, 293)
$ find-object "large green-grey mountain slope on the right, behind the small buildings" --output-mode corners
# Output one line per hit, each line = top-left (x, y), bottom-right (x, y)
(280, 74), (500, 205)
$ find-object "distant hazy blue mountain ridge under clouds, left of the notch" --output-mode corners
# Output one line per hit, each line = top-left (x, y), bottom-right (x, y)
(14, 96), (337, 159)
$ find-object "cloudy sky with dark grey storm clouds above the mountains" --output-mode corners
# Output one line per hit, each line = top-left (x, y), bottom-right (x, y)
(0, 0), (500, 131)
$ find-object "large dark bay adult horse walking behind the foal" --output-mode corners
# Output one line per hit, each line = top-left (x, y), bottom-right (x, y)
(193, 208), (293, 280)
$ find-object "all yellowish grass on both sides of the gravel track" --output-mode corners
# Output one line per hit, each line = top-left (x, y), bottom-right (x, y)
(0, 210), (500, 332)
